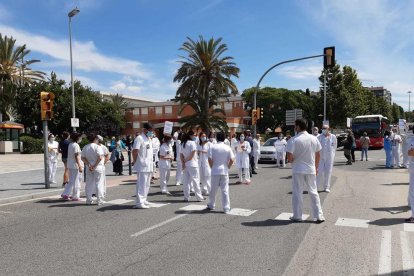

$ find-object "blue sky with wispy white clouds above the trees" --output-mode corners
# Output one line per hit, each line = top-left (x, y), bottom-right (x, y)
(0, 0), (414, 110)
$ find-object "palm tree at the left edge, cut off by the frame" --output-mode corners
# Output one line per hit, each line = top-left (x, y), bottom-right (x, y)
(0, 34), (45, 121)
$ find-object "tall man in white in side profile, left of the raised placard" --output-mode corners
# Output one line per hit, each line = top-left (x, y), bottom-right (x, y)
(132, 123), (154, 209)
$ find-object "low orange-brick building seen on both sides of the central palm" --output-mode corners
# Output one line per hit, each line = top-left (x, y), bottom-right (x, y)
(123, 96), (251, 135)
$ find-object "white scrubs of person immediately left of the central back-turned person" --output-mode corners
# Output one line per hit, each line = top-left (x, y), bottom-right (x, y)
(181, 141), (204, 201)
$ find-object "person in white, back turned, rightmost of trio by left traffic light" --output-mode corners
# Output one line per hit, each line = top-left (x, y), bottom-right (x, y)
(81, 134), (105, 205)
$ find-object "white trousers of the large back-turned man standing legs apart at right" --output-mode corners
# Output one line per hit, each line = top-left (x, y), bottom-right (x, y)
(292, 173), (323, 219)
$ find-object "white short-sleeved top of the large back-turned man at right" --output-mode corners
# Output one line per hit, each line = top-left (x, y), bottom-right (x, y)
(288, 131), (322, 174)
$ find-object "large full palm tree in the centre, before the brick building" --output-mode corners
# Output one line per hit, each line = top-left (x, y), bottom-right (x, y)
(174, 36), (240, 132)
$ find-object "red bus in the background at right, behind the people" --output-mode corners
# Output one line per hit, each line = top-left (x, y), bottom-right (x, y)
(352, 115), (390, 149)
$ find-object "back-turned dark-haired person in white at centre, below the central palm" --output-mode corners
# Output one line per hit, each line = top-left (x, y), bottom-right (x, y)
(207, 132), (234, 214)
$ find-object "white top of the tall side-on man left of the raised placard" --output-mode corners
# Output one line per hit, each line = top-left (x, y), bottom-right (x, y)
(132, 133), (154, 172)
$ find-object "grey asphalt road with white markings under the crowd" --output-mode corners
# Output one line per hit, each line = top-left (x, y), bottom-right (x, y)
(0, 151), (414, 275)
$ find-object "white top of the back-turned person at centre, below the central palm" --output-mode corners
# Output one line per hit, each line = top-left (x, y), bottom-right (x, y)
(209, 142), (234, 175)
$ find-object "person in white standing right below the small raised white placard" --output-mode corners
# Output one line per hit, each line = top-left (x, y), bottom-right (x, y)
(158, 135), (174, 195)
